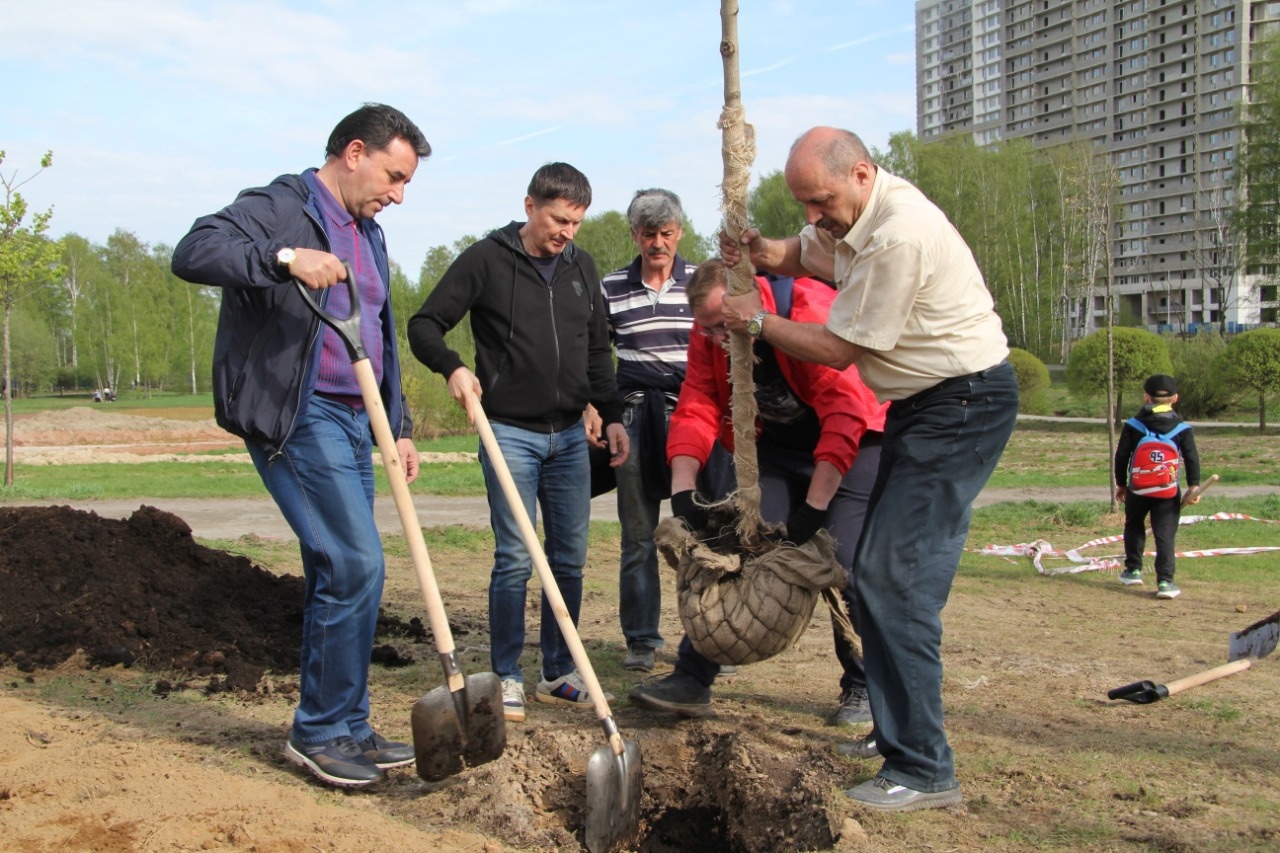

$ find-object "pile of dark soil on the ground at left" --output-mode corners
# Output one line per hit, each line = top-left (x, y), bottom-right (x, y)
(0, 506), (312, 690)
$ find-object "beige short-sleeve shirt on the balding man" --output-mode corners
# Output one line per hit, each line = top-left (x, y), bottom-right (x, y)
(800, 169), (1009, 400)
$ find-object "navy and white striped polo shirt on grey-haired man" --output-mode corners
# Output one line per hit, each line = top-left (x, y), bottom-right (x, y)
(602, 255), (695, 397)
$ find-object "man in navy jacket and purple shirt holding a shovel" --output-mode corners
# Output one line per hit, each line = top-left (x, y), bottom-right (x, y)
(173, 104), (431, 786)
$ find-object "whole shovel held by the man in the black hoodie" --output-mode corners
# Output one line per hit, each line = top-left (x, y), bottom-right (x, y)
(467, 394), (644, 853)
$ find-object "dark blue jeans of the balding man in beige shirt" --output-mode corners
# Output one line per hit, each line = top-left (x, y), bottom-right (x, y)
(855, 362), (1018, 792)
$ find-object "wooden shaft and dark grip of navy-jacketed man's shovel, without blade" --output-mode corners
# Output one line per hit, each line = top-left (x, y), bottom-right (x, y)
(293, 263), (466, 693)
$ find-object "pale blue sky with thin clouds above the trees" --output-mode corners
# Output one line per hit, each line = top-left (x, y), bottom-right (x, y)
(0, 0), (915, 277)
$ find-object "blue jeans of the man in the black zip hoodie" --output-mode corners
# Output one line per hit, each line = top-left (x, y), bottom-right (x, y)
(480, 421), (591, 681)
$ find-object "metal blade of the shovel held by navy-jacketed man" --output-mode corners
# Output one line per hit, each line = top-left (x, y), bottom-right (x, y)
(410, 672), (507, 781)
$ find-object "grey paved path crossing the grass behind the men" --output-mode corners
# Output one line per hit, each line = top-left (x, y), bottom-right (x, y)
(17, 485), (1280, 539)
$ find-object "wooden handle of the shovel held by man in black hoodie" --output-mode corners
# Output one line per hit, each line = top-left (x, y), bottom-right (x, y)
(466, 393), (625, 742)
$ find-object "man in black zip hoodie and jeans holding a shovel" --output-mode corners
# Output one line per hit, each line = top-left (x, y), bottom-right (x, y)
(408, 163), (630, 722)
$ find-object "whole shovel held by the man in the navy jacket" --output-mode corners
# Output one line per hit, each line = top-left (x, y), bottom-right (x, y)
(294, 272), (507, 781)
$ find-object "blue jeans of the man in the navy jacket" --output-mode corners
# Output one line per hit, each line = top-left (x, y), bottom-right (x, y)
(246, 397), (385, 743)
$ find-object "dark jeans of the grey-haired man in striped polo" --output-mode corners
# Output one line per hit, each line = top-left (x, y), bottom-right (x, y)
(614, 406), (666, 648)
